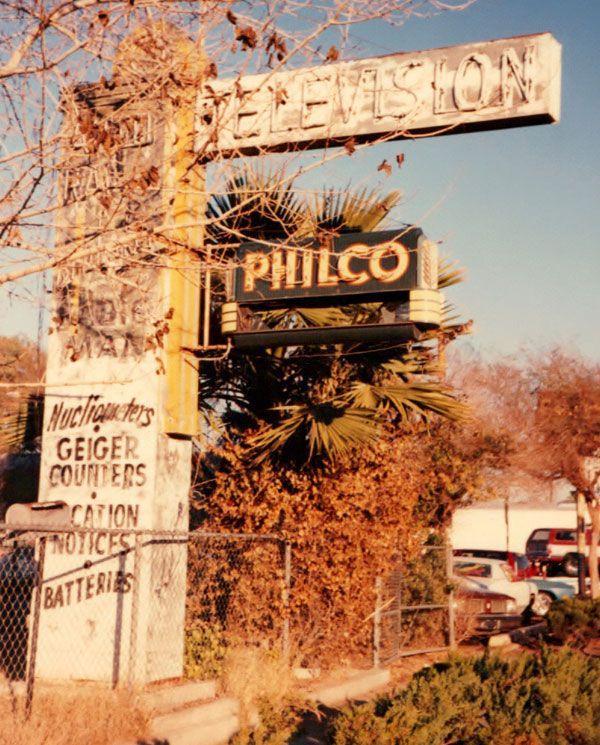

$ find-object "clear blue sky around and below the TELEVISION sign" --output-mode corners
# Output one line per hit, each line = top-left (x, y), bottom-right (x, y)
(0, 0), (600, 361)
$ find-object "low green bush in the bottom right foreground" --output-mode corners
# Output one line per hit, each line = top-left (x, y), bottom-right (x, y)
(330, 648), (600, 745)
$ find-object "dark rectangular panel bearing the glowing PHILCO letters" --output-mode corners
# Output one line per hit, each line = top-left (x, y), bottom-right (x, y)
(234, 228), (424, 304)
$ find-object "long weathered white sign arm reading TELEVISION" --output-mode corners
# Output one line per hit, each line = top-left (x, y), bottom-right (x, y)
(194, 33), (561, 158)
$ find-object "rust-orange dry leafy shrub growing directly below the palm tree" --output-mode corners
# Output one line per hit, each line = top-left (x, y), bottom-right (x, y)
(198, 435), (468, 665)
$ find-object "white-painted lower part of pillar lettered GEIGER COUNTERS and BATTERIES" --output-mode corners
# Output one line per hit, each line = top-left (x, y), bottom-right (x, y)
(36, 372), (190, 682)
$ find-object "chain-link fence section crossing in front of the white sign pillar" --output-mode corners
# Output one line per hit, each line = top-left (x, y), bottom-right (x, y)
(0, 525), (291, 701)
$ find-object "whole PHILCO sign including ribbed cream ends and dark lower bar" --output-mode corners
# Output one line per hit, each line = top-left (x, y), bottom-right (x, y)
(222, 227), (442, 348)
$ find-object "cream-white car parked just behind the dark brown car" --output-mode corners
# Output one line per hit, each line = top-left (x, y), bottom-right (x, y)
(452, 557), (547, 615)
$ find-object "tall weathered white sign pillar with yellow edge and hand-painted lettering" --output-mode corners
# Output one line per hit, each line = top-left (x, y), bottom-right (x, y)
(35, 27), (204, 685)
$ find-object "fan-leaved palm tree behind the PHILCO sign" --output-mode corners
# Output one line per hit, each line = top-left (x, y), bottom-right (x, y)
(200, 168), (464, 463)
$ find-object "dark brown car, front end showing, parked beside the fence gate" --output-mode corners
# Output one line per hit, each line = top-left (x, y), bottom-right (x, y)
(456, 587), (523, 634)
